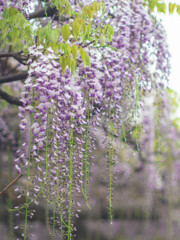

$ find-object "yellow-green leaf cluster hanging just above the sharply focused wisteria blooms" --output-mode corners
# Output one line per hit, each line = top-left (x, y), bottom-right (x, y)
(36, 1), (114, 74)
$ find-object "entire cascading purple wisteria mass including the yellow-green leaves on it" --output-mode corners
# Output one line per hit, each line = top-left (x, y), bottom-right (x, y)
(0, 0), (175, 239)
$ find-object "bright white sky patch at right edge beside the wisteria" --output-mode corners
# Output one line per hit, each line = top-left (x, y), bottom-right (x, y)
(161, 0), (180, 117)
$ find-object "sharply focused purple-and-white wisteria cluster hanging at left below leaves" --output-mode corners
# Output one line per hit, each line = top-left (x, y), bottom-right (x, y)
(13, 46), (90, 237)
